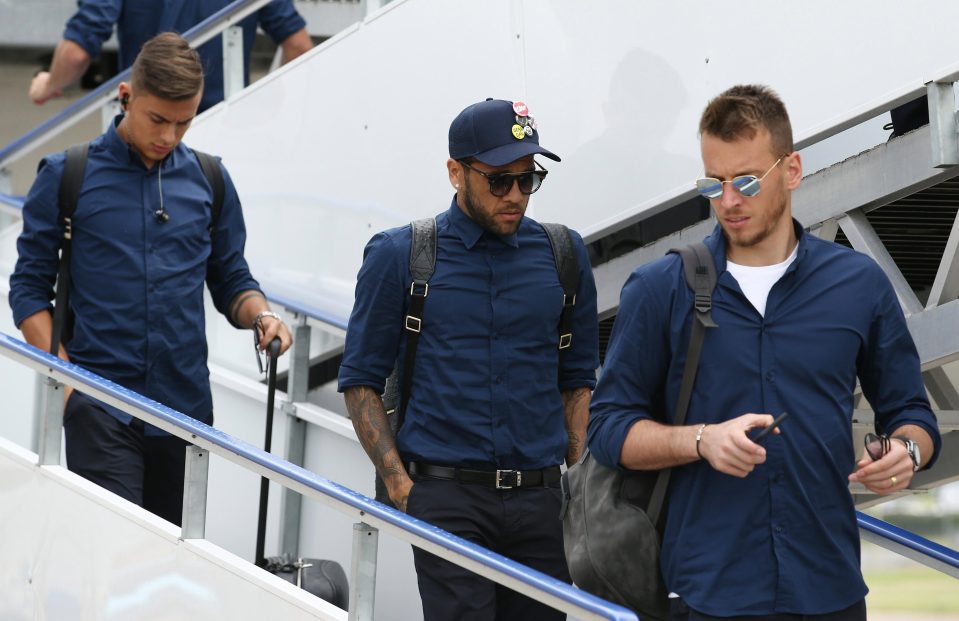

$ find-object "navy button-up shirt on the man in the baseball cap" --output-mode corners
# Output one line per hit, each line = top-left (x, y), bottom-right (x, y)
(339, 200), (599, 469)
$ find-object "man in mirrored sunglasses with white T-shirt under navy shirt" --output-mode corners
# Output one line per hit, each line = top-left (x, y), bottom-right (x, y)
(589, 86), (941, 621)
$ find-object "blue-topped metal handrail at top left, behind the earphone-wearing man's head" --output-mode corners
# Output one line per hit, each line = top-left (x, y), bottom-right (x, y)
(0, 0), (270, 170)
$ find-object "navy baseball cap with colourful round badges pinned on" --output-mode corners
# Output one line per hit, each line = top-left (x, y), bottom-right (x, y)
(450, 98), (560, 166)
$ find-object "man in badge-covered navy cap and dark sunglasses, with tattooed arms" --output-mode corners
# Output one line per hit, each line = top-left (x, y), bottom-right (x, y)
(339, 99), (599, 621)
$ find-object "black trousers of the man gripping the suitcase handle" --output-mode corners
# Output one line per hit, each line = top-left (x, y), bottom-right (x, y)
(63, 391), (187, 526)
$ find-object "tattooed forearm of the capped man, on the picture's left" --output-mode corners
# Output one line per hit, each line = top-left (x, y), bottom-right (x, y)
(343, 386), (406, 481)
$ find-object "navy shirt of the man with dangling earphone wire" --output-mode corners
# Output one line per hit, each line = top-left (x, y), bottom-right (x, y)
(10, 117), (259, 434)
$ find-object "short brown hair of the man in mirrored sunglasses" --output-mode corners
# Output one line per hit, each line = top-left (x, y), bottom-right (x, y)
(699, 84), (794, 157)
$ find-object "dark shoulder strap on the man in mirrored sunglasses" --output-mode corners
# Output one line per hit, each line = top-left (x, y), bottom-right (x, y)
(646, 242), (718, 524)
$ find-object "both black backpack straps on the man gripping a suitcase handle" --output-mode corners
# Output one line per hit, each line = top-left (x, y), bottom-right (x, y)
(50, 142), (225, 356)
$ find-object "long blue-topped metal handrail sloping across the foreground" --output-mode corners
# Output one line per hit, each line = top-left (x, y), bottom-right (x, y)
(0, 333), (637, 621)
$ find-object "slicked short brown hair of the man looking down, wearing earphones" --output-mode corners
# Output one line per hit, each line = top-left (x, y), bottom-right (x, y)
(130, 32), (203, 101)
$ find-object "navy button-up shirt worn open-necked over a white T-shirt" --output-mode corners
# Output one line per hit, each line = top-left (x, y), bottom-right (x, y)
(589, 223), (941, 616)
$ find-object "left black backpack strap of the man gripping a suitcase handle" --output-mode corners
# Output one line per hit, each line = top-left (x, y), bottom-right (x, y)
(50, 142), (90, 356)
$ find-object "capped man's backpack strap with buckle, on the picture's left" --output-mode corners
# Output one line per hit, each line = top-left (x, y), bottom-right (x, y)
(397, 218), (436, 429)
